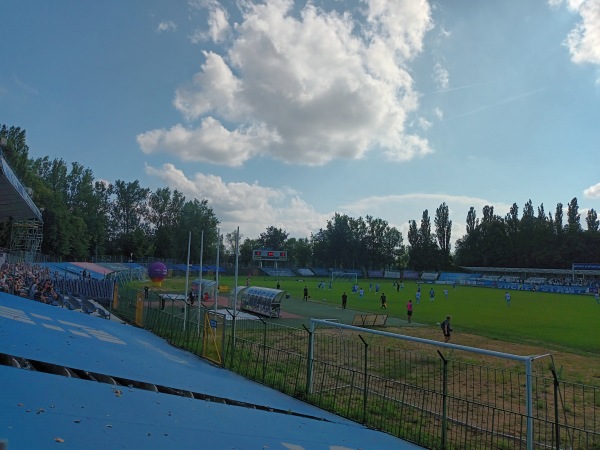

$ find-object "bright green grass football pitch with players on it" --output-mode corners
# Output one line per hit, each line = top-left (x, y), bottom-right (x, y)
(220, 277), (600, 353)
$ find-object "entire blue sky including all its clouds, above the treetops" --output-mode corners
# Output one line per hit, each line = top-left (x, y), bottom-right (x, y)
(0, 0), (600, 246)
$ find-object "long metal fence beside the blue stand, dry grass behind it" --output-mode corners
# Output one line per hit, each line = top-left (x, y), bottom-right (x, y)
(114, 289), (600, 450)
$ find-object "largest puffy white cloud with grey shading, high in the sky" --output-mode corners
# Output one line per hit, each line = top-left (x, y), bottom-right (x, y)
(138, 0), (432, 166)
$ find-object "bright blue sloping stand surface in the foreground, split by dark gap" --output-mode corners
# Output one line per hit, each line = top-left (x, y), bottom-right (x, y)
(0, 293), (420, 450)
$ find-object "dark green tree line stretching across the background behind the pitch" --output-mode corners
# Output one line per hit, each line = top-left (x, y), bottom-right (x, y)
(0, 125), (600, 271)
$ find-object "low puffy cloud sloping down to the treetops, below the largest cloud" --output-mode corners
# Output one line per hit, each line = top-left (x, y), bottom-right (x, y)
(146, 164), (333, 238)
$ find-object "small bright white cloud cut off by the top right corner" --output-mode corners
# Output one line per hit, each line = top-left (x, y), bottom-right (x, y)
(564, 0), (600, 64)
